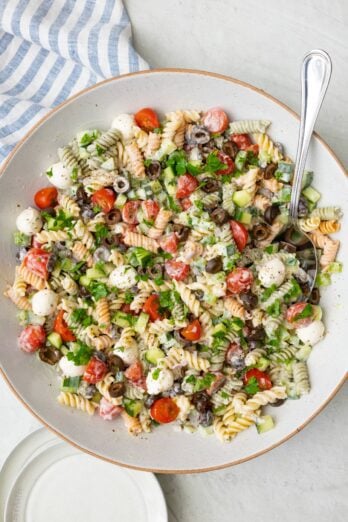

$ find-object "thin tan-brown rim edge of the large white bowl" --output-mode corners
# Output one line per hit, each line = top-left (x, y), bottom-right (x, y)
(0, 68), (348, 475)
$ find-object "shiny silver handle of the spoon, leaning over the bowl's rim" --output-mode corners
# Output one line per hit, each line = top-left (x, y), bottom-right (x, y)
(290, 50), (332, 222)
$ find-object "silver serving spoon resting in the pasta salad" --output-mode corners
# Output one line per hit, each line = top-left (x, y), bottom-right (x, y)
(281, 50), (332, 299)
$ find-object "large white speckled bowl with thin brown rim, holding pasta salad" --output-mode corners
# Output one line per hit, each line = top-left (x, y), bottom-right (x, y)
(0, 70), (348, 473)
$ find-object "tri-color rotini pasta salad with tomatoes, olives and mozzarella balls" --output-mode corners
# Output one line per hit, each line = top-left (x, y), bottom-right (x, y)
(5, 108), (342, 441)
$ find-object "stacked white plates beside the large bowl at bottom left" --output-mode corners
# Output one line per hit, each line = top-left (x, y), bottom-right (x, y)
(0, 429), (168, 522)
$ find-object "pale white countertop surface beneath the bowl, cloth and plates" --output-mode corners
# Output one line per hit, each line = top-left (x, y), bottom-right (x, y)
(0, 0), (348, 522)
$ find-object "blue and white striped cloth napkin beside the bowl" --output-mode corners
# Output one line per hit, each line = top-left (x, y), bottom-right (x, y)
(0, 0), (148, 162)
